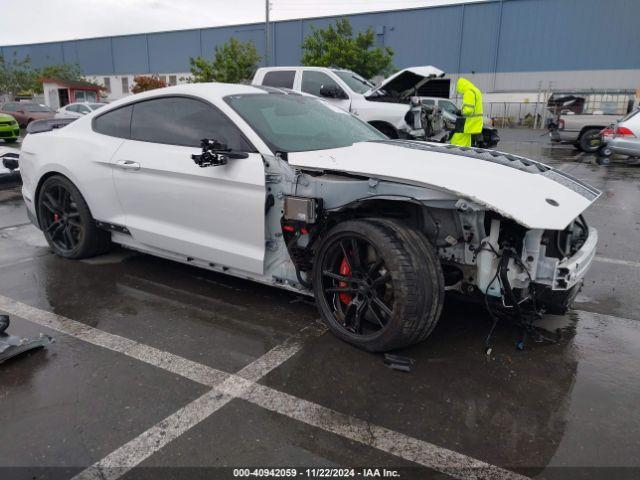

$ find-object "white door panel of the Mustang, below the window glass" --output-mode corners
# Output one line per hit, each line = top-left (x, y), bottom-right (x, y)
(113, 140), (265, 274)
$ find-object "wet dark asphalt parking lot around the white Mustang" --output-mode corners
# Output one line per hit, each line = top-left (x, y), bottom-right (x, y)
(0, 131), (640, 479)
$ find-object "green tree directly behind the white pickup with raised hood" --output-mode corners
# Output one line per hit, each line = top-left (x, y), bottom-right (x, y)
(302, 18), (393, 78)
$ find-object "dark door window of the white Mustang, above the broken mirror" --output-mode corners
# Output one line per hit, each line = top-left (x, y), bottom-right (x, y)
(131, 97), (253, 152)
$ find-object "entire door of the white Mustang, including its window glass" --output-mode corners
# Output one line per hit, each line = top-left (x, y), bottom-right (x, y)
(113, 96), (265, 274)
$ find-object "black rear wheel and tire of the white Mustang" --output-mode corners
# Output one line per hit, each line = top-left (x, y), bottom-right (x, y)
(37, 175), (111, 259)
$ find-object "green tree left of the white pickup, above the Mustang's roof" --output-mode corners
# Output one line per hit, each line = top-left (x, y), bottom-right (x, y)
(189, 37), (261, 83)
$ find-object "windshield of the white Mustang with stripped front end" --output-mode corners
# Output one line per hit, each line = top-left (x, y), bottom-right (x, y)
(225, 93), (386, 152)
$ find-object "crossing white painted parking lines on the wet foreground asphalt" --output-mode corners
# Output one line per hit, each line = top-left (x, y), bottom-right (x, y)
(0, 295), (527, 480)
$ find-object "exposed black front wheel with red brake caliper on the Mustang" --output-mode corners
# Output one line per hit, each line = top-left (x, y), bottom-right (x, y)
(313, 219), (444, 352)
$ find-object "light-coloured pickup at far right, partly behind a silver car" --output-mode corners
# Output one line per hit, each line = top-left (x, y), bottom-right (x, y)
(548, 113), (620, 153)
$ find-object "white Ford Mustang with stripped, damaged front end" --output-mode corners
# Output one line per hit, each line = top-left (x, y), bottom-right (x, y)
(20, 83), (600, 351)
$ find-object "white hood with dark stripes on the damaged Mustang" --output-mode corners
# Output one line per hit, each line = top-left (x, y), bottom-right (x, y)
(288, 140), (600, 230)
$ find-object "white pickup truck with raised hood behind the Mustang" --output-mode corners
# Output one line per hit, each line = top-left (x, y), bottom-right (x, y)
(252, 66), (449, 142)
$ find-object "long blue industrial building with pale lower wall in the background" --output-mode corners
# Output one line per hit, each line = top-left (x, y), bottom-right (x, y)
(0, 0), (640, 103)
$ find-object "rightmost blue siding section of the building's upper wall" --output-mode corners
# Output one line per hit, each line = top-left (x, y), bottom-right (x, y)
(498, 0), (640, 72)
